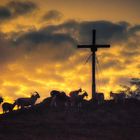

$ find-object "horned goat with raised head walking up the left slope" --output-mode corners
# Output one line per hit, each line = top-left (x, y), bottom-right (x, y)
(14, 92), (40, 108)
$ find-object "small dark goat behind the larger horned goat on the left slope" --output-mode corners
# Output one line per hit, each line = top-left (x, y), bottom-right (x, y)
(2, 102), (15, 113)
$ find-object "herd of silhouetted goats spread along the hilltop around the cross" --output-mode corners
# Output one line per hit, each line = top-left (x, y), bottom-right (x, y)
(0, 88), (139, 113)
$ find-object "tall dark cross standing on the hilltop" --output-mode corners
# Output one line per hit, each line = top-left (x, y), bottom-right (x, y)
(77, 30), (110, 100)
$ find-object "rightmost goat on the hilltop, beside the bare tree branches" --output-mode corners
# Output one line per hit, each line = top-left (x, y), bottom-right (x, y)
(110, 91), (126, 103)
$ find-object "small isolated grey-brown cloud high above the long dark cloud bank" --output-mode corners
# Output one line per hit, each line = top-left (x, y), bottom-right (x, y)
(42, 10), (63, 21)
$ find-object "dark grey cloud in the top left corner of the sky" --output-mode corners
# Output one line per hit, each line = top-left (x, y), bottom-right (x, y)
(0, 1), (37, 22)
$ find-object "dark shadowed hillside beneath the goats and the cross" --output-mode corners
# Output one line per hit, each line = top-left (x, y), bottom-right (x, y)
(0, 100), (140, 140)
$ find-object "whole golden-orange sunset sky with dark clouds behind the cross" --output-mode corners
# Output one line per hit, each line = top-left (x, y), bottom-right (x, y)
(0, 0), (140, 105)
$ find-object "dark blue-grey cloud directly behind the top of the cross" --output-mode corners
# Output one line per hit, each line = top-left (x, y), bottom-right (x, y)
(80, 21), (127, 43)
